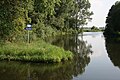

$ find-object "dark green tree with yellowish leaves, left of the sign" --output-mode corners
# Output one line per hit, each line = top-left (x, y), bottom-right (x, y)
(0, 0), (33, 41)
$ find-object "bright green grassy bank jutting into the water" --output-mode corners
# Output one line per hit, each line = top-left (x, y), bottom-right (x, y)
(0, 40), (73, 62)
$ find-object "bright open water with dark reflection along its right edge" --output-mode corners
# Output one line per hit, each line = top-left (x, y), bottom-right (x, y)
(73, 32), (120, 80)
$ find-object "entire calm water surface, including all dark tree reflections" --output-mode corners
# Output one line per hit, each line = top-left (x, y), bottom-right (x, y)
(0, 32), (120, 80)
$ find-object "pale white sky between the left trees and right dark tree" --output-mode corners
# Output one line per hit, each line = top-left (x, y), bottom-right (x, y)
(85, 0), (120, 27)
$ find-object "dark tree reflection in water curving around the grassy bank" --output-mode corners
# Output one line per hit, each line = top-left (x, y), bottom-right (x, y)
(0, 35), (91, 80)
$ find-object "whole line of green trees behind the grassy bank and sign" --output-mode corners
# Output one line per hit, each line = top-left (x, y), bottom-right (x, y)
(0, 0), (93, 40)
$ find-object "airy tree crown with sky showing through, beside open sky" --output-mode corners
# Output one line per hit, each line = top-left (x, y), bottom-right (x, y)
(75, 0), (93, 28)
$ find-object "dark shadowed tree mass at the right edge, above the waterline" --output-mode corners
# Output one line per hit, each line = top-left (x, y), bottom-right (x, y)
(104, 1), (120, 35)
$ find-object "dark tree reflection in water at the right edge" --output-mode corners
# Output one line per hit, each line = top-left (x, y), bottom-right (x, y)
(106, 38), (120, 68)
